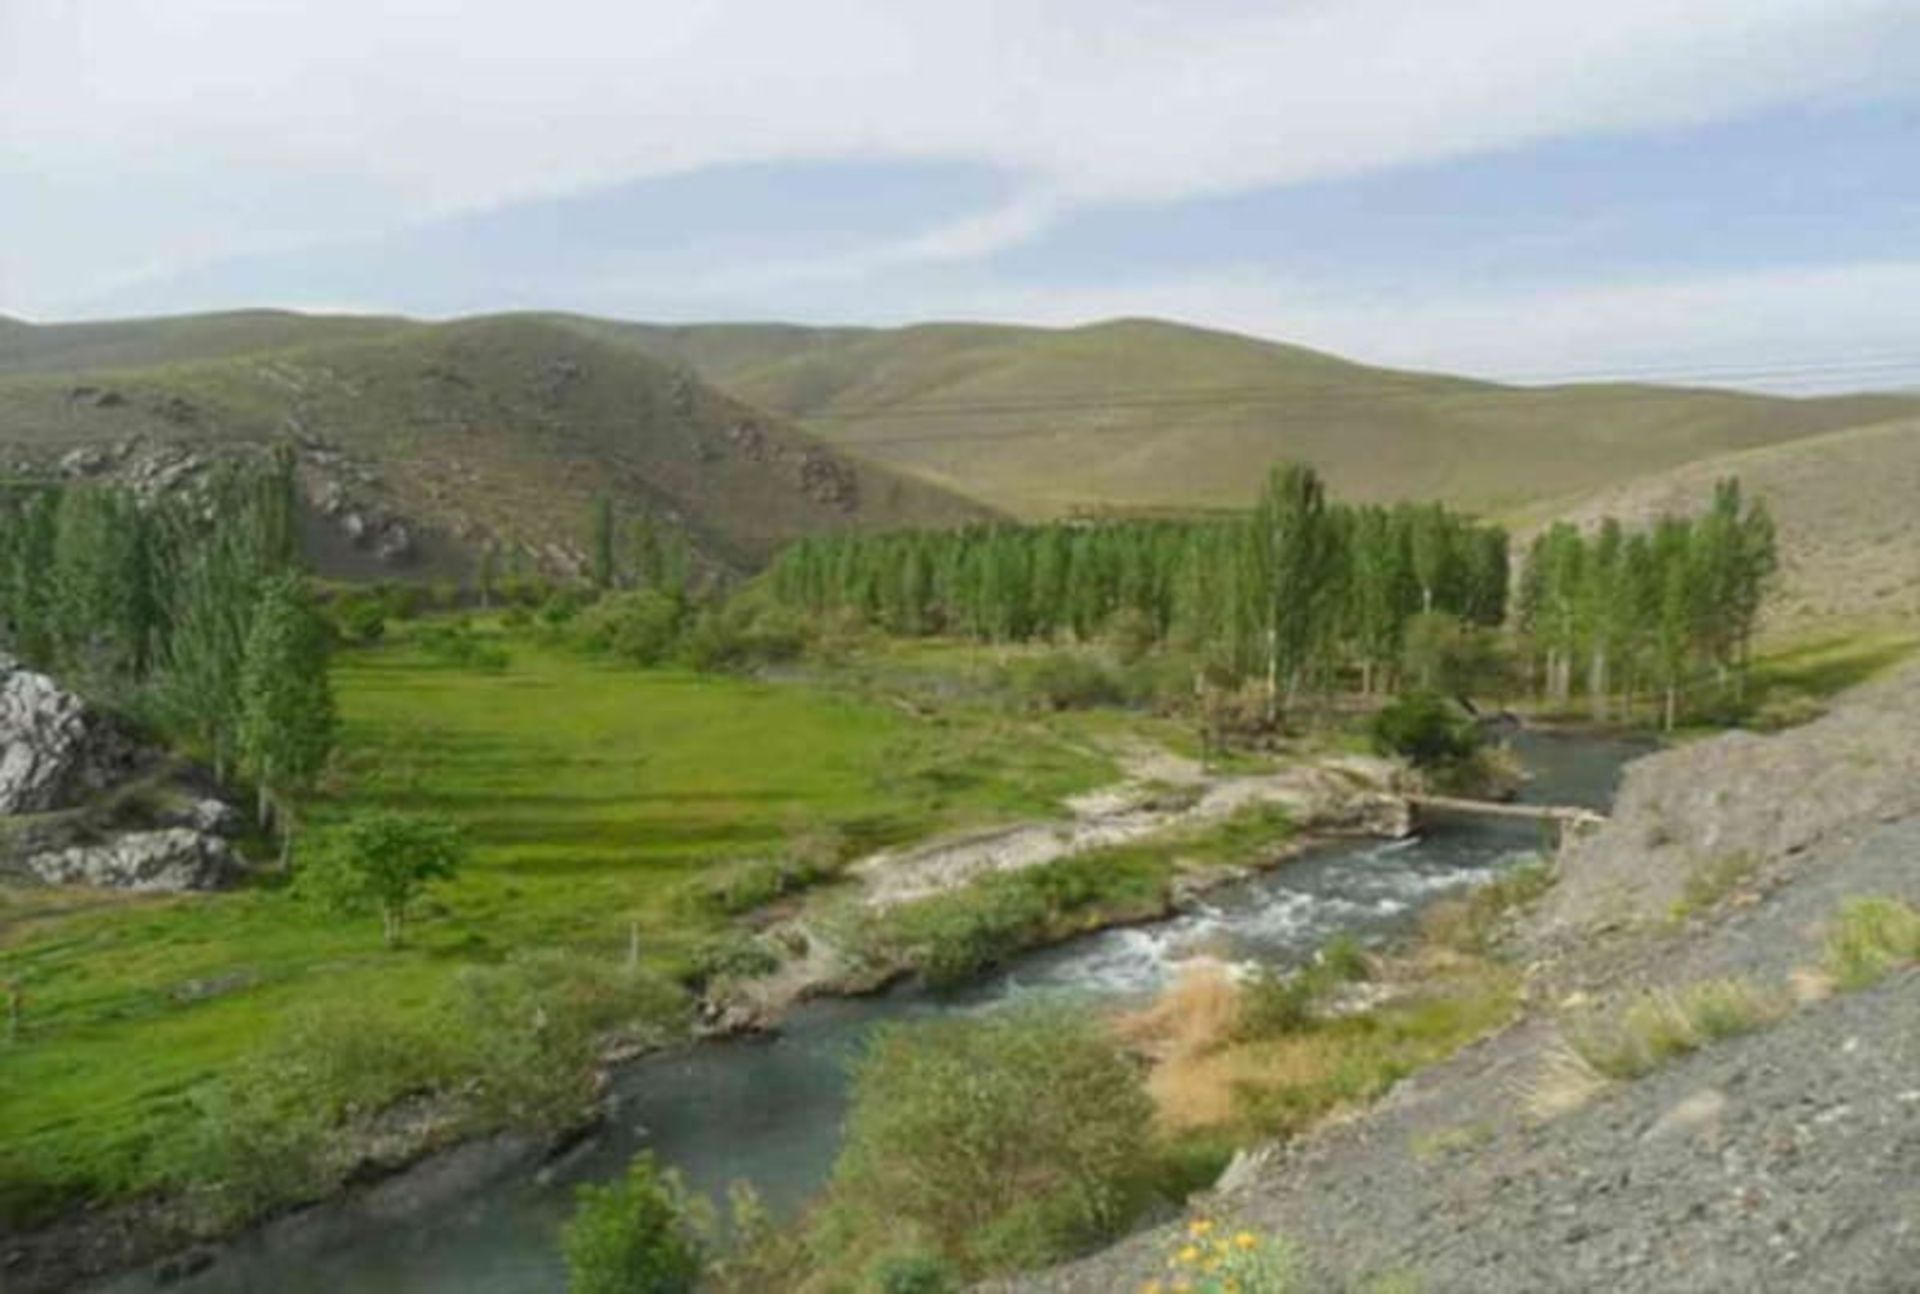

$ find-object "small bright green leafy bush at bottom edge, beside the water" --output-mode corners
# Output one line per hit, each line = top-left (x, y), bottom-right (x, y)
(561, 1156), (703, 1294)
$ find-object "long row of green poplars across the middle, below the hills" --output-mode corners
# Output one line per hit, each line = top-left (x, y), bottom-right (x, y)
(768, 465), (1509, 699)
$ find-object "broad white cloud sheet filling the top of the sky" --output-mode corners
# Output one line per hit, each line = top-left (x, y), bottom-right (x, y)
(0, 0), (1920, 312)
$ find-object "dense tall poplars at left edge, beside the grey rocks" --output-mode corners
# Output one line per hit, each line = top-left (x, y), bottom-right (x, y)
(0, 455), (336, 837)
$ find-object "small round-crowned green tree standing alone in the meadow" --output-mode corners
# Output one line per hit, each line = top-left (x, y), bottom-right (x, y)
(311, 810), (467, 948)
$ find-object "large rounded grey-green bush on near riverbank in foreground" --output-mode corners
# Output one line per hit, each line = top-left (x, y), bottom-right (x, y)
(816, 1008), (1154, 1277)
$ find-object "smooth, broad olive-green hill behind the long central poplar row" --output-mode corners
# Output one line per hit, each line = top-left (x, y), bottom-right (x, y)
(602, 321), (1920, 516)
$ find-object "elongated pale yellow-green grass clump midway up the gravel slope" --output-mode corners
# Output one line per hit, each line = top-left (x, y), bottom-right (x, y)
(1563, 979), (1786, 1079)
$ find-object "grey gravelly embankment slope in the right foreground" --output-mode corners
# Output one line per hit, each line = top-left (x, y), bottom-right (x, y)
(995, 670), (1920, 1294)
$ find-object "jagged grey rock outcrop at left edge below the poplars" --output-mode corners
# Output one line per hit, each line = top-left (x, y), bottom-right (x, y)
(0, 657), (242, 891)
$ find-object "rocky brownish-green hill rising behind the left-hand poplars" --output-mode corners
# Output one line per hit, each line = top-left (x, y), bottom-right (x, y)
(0, 315), (987, 574)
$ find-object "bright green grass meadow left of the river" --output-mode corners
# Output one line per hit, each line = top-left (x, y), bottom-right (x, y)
(0, 641), (1116, 1194)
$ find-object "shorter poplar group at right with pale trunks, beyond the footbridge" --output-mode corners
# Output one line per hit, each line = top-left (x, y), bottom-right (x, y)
(1517, 480), (1778, 730)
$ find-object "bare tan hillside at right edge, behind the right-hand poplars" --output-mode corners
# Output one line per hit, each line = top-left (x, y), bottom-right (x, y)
(1530, 419), (1920, 632)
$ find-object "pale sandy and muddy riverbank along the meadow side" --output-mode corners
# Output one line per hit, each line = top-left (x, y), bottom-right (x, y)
(0, 725), (1407, 1290)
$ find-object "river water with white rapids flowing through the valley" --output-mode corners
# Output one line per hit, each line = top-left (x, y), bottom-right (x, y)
(108, 733), (1645, 1294)
